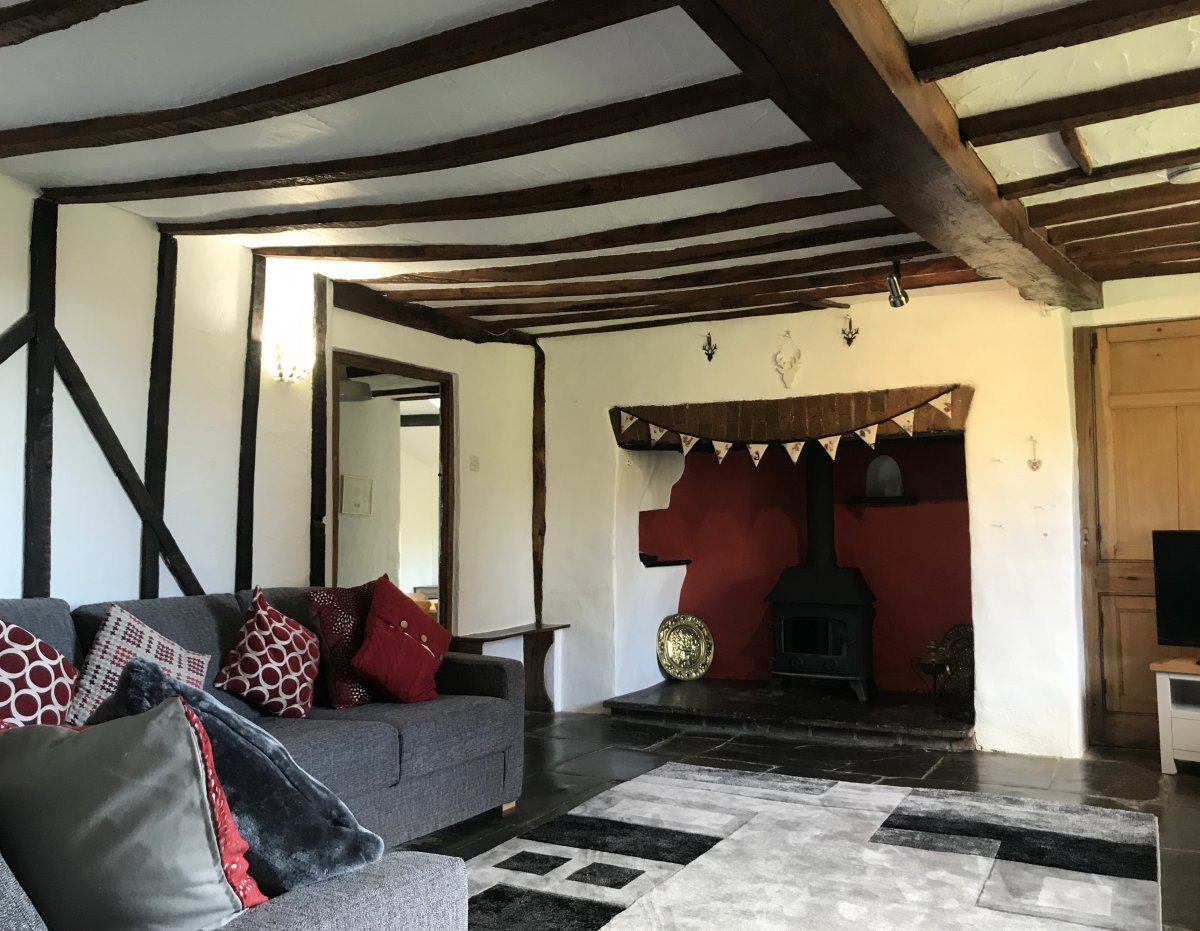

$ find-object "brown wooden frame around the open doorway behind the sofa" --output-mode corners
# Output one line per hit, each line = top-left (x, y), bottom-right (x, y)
(329, 349), (458, 631)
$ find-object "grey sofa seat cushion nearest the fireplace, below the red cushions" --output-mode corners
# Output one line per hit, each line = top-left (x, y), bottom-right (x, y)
(307, 695), (521, 779)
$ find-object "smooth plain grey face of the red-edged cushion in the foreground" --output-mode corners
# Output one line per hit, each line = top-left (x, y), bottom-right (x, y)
(0, 701), (242, 931)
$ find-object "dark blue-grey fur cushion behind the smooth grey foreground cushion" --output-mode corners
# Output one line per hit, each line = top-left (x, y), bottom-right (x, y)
(88, 659), (384, 896)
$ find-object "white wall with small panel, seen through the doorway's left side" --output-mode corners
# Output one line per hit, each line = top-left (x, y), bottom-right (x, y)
(332, 397), (400, 585)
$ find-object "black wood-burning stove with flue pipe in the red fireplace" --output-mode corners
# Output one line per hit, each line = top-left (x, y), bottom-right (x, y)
(767, 450), (875, 702)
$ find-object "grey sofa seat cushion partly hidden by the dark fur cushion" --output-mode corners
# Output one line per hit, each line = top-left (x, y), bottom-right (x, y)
(254, 717), (400, 798)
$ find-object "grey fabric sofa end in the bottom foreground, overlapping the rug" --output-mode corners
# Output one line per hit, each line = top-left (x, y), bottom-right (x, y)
(229, 851), (467, 931)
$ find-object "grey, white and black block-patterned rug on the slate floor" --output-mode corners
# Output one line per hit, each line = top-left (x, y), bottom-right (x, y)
(468, 763), (1160, 931)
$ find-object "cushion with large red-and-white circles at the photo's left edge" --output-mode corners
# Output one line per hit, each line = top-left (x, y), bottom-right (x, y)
(0, 620), (79, 727)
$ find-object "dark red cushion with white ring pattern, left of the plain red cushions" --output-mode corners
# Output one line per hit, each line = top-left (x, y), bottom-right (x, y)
(212, 587), (320, 717)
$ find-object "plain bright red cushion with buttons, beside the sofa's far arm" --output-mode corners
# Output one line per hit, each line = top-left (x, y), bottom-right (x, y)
(354, 578), (450, 702)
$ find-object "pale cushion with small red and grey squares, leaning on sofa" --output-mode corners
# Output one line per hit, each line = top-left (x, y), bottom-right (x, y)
(67, 605), (209, 725)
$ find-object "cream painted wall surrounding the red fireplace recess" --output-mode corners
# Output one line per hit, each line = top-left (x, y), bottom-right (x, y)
(545, 286), (1084, 756)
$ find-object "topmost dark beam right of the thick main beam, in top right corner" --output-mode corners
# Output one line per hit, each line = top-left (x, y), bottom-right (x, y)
(910, 0), (1200, 80)
